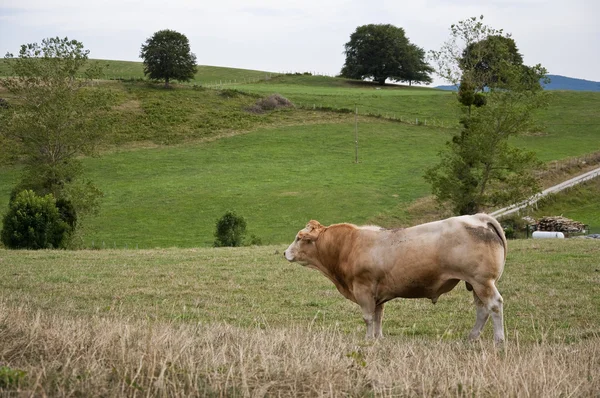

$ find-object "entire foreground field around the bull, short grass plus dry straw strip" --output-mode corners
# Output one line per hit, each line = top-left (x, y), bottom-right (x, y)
(0, 239), (600, 397)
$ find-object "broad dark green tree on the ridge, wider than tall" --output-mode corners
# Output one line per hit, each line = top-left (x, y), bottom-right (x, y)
(341, 24), (431, 85)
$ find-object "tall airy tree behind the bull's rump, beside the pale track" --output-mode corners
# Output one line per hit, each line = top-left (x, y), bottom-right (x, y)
(425, 17), (547, 214)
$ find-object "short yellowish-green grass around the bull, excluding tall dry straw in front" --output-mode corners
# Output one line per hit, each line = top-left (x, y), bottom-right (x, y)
(0, 239), (600, 342)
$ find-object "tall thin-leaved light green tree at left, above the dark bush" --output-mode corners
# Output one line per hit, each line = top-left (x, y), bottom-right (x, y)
(0, 37), (111, 243)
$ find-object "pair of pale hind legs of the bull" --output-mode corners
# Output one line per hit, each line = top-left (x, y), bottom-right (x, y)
(469, 281), (504, 343)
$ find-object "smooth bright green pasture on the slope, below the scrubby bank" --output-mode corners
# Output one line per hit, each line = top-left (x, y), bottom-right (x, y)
(79, 122), (446, 248)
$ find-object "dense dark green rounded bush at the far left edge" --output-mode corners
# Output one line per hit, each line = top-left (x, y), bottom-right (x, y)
(0, 190), (70, 250)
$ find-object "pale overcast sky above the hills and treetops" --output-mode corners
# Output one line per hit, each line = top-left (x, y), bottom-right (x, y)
(0, 0), (600, 84)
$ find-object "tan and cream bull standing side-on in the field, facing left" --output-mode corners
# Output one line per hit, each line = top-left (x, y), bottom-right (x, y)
(284, 214), (506, 342)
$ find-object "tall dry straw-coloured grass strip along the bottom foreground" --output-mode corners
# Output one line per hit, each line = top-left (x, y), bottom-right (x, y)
(0, 302), (600, 397)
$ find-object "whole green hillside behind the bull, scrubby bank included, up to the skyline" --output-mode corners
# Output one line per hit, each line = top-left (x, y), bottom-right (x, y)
(0, 61), (600, 248)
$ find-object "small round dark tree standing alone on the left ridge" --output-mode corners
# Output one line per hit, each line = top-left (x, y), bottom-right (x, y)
(140, 29), (197, 87)
